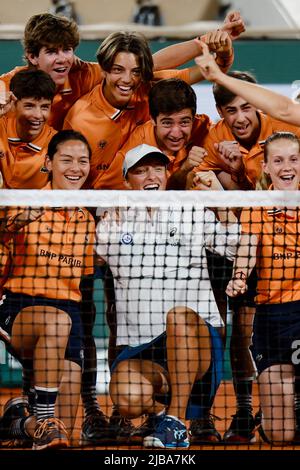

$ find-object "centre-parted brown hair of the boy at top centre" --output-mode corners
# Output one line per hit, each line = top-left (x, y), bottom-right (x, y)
(97, 31), (153, 82)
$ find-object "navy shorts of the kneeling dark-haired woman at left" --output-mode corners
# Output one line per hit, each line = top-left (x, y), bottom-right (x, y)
(0, 291), (83, 367)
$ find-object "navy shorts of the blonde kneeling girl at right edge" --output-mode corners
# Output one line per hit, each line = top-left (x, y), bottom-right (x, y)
(251, 301), (300, 374)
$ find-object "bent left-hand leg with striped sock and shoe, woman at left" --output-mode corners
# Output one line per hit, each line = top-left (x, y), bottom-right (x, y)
(11, 306), (72, 450)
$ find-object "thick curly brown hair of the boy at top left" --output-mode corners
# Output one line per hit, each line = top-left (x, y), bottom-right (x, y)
(23, 13), (79, 57)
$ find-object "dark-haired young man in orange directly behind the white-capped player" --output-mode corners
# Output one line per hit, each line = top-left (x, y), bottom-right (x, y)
(95, 78), (211, 190)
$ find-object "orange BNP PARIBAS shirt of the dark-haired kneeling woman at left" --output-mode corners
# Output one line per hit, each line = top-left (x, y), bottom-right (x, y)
(5, 196), (95, 302)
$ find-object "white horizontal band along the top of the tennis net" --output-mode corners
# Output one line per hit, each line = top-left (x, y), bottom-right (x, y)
(0, 190), (300, 207)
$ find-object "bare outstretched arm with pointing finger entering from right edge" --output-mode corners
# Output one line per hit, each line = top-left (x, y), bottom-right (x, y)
(195, 42), (300, 126)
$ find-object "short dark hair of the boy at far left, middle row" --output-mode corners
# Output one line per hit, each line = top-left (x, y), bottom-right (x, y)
(9, 69), (56, 101)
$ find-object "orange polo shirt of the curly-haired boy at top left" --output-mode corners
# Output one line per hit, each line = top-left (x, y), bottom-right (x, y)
(0, 57), (103, 130)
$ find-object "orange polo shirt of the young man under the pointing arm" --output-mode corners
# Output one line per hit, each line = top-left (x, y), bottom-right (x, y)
(195, 111), (300, 188)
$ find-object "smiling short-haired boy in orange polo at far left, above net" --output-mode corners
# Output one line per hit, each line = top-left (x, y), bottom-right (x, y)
(0, 69), (56, 189)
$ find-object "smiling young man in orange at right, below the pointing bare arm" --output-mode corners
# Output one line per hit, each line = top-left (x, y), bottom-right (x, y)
(196, 71), (300, 189)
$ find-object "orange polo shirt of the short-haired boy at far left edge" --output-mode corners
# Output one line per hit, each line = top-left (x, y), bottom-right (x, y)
(0, 114), (57, 189)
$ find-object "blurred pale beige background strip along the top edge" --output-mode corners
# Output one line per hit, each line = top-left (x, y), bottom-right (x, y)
(0, 0), (300, 33)
